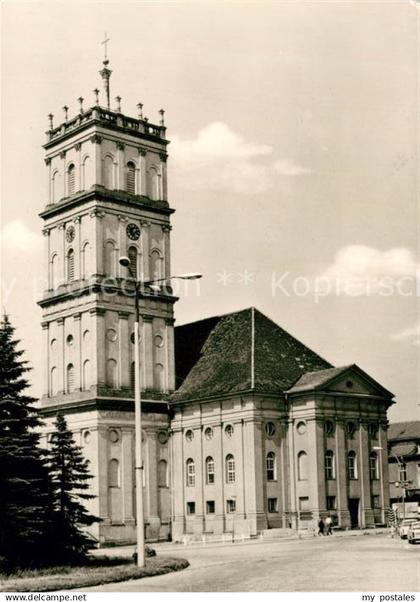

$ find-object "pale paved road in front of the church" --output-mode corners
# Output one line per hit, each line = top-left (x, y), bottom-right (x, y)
(83, 535), (420, 592)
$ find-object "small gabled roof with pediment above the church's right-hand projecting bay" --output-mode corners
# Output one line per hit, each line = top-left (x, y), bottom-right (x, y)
(287, 364), (393, 398)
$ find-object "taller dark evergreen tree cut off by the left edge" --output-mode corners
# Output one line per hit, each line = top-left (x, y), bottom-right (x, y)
(0, 316), (52, 567)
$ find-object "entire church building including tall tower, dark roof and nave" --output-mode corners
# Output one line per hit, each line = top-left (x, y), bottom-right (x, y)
(39, 60), (393, 543)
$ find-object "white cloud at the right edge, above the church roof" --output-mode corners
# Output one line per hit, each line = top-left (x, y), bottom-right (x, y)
(317, 245), (420, 296)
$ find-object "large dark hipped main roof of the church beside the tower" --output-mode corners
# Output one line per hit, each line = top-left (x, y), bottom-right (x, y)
(171, 308), (331, 402)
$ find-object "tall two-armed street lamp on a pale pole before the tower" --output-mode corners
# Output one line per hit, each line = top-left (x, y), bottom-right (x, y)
(119, 257), (202, 567)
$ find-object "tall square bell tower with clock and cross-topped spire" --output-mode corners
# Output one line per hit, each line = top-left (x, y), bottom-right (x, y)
(39, 55), (176, 542)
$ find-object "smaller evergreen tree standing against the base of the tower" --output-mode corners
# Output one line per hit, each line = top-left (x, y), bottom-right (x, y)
(50, 414), (100, 562)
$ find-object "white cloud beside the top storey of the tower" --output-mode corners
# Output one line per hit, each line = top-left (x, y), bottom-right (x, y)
(171, 121), (310, 194)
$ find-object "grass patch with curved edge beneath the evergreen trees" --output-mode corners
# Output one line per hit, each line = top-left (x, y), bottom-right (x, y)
(0, 556), (189, 592)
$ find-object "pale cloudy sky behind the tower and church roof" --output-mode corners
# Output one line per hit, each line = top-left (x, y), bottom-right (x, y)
(1, 0), (420, 421)
